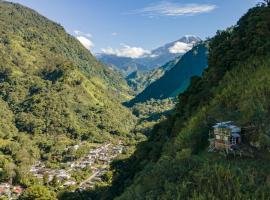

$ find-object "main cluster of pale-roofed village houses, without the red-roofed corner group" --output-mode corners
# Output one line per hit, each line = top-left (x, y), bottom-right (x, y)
(30, 144), (123, 189)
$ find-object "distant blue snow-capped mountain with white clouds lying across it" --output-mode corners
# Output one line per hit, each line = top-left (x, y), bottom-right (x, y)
(96, 35), (201, 75)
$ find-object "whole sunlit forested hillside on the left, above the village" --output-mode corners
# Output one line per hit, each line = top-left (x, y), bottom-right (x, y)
(0, 1), (135, 184)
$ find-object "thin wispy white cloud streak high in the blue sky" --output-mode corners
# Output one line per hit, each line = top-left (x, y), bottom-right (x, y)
(130, 1), (217, 17)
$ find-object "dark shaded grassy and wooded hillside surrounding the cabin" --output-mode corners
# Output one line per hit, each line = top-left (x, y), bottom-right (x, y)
(97, 5), (270, 200)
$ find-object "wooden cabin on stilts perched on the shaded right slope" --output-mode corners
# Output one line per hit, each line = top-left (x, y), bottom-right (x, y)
(209, 121), (241, 151)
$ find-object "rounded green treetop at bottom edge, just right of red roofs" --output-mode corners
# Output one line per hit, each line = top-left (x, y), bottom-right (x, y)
(20, 185), (57, 200)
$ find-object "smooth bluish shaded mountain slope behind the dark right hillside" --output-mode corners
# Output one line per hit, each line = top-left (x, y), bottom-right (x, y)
(128, 44), (207, 105)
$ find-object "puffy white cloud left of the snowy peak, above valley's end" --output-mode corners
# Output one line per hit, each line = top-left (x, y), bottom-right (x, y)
(101, 44), (151, 58)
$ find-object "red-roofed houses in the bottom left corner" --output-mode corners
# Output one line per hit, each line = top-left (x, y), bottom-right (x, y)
(0, 183), (24, 199)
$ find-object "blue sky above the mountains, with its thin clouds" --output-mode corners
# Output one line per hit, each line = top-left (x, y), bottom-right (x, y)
(7, 0), (258, 53)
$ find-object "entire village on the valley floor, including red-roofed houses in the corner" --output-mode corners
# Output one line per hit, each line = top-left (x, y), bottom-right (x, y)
(0, 142), (123, 199)
